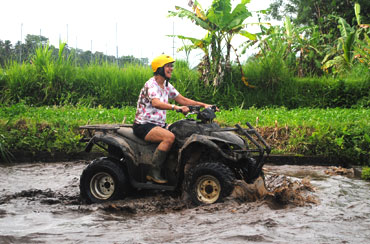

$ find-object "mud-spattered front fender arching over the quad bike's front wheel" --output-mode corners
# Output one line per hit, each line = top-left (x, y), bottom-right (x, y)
(178, 134), (238, 168)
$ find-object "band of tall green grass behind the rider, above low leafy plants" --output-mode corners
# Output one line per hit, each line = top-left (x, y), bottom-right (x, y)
(0, 44), (370, 109)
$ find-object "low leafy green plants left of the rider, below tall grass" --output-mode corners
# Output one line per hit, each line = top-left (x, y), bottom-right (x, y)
(0, 103), (135, 161)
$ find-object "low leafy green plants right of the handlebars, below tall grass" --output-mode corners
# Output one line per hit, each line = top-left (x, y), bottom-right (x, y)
(217, 108), (370, 165)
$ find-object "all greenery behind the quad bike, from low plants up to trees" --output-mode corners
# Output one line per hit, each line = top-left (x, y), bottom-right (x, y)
(0, 0), (370, 171)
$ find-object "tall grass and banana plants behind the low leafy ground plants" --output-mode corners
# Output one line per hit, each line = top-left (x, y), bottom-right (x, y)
(0, 0), (370, 109)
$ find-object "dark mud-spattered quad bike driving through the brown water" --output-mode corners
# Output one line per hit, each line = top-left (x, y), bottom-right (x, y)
(80, 106), (271, 205)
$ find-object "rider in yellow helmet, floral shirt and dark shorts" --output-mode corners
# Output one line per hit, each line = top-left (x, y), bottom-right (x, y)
(133, 54), (211, 184)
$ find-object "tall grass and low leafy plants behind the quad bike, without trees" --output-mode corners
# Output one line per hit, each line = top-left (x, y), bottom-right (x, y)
(0, 44), (370, 165)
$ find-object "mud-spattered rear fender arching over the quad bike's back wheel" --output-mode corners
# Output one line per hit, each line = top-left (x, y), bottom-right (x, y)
(85, 132), (136, 162)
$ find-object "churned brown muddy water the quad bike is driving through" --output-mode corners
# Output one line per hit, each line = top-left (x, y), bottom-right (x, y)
(0, 162), (370, 243)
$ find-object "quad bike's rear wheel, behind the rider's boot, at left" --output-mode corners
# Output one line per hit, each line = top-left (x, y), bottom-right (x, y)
(80, 158), (128, 203)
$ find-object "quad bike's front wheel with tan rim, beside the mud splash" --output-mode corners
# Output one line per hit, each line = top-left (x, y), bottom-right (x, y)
(185, 163), (235, 205)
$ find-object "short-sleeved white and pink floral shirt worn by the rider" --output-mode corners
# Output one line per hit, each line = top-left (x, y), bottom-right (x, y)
(134, 77), (180, 127)
